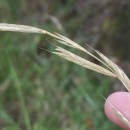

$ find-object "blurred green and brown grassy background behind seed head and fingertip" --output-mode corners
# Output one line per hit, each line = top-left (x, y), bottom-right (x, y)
(0, 0), (130, 130)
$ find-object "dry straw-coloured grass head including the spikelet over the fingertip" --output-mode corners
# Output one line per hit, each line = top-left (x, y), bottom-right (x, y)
(0, 23), (130, 128)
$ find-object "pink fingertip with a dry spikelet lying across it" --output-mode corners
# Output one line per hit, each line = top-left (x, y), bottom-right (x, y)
(104, 92), (130, 130)
